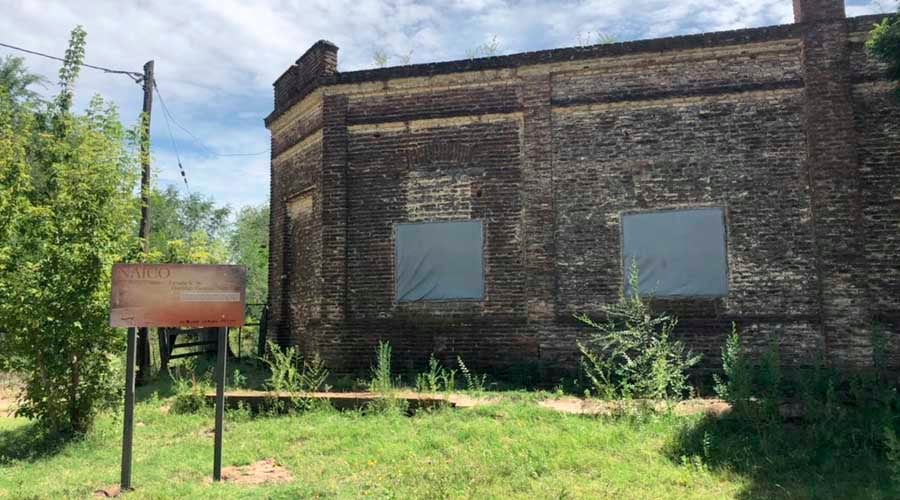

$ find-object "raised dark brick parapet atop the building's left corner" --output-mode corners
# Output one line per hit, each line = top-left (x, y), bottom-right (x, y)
(274, 40), (338, 114)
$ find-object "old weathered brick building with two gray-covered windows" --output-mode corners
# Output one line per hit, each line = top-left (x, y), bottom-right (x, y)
(266, 0), (900, 371)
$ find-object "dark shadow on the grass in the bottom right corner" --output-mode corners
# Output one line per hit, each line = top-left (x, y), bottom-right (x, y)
(666, 416), (900, 499)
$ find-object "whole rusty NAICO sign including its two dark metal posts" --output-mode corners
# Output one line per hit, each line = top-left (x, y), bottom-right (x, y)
(109, 264), (247, 491)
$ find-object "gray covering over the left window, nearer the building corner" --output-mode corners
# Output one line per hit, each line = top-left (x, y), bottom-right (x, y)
(394, 220), (484, 302)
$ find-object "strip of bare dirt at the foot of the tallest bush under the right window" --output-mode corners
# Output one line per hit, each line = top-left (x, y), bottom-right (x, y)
(540, 398), (731, 416)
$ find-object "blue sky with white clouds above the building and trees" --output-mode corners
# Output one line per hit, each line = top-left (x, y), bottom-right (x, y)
(0, 0), (895, 209)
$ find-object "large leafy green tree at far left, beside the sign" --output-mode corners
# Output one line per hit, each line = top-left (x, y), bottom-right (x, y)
(0, 27), (138, 433)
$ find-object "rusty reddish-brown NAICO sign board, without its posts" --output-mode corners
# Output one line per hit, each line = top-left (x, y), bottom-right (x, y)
(109, 264), (247, 328)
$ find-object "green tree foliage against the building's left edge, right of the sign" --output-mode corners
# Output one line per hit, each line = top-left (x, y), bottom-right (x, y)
(228, 204), (269, 304)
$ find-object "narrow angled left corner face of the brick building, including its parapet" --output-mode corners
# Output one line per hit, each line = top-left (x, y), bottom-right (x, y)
(266, 41), (337, 346)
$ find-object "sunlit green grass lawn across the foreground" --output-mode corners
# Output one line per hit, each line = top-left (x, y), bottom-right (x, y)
(0, 397), (897, 499)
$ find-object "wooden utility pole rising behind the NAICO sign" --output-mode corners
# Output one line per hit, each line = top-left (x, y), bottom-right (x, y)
(137, 61), (154, 383)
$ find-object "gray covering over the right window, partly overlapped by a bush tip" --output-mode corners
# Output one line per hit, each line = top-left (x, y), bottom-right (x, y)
(622, 208), (728, 297)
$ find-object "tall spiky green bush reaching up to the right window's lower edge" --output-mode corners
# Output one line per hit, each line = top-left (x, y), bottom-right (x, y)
(575, 262), (700, 399)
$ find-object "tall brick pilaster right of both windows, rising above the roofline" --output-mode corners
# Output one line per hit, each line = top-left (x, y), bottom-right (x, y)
(794, 0), (871, 366)
